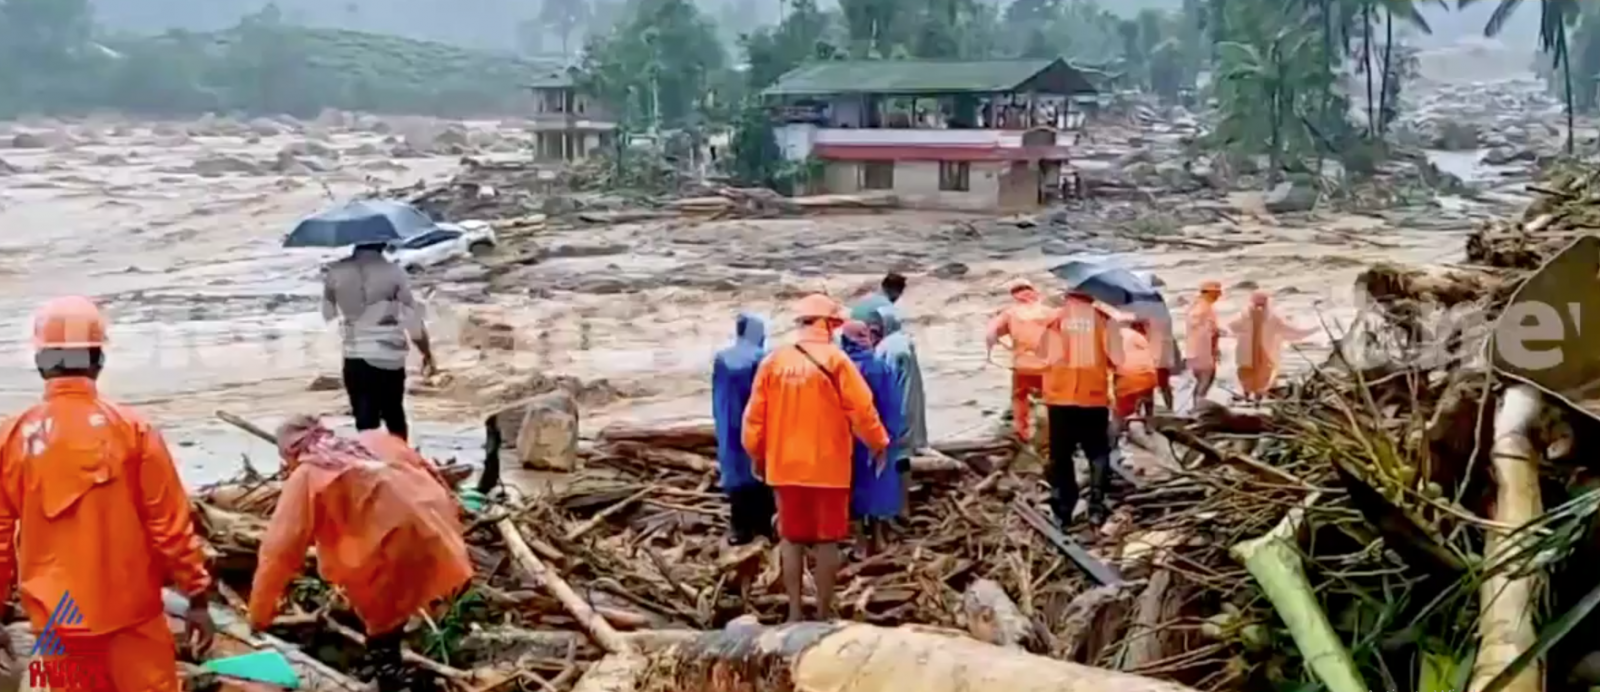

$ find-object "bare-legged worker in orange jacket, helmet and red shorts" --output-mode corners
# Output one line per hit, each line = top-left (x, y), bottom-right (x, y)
(744, 295), (891, 622)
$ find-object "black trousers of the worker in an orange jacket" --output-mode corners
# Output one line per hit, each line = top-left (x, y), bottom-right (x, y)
(1046, 405), (1110, 525)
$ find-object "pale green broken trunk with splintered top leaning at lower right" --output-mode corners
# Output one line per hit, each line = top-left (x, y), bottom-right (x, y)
(1230, 493), (1368, 692)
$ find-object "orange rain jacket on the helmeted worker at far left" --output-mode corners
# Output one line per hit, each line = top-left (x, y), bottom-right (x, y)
(0, 378), (211, 637)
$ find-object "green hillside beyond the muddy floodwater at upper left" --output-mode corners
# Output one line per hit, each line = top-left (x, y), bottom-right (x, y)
(0, 0), (556, 117)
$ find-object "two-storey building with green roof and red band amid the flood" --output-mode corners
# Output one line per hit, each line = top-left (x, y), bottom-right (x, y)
(763, 59), (1094, 210)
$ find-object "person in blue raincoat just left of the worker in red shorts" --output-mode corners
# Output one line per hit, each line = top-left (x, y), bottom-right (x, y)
(710, 312), (776, 545)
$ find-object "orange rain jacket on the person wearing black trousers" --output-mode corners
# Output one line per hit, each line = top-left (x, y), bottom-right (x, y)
(1043, 295), (1112, 408)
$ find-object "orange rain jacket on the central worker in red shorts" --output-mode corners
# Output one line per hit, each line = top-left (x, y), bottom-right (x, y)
(744, 325), (890, 489)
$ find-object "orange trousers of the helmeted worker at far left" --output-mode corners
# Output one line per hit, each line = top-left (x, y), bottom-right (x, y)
(22, 615), (179, 692)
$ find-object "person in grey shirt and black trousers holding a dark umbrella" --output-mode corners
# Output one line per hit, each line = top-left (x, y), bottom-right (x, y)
(322, 245), (434, 439)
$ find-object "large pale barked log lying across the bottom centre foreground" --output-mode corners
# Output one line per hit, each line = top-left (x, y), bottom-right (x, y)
(576, 623), (1194, 692)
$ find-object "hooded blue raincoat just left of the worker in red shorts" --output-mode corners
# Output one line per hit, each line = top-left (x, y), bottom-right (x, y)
(710, 312), (766, 492)
